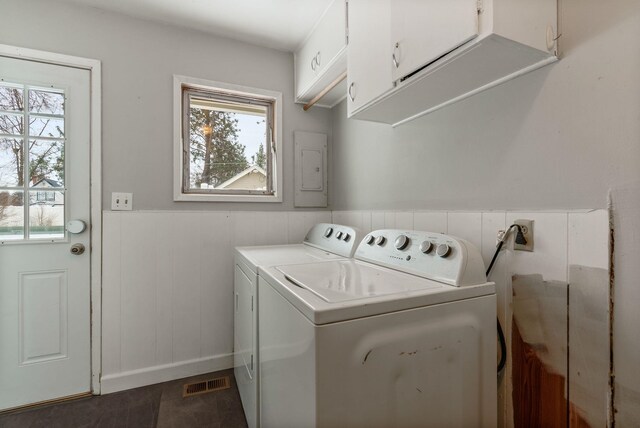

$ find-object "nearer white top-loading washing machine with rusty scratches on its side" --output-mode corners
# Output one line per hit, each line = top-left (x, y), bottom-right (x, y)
(259, 230), (497, 428)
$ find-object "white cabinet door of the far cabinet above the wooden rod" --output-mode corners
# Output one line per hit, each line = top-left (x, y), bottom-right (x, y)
(295, 0), (346, 98)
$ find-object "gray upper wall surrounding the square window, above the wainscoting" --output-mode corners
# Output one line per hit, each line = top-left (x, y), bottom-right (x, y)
(0, 0), (331, 210)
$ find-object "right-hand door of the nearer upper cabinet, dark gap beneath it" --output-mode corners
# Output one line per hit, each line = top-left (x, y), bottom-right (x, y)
(389, 0), (478, 81)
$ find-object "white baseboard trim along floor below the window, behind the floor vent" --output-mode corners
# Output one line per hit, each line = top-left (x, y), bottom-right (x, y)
(100, 354), (233, 394)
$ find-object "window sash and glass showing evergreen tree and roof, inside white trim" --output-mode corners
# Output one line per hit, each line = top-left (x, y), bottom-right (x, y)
(183, 88), (273, 194)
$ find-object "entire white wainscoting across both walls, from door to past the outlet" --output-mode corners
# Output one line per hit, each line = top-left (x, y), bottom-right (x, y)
(102, 206), (609, 418)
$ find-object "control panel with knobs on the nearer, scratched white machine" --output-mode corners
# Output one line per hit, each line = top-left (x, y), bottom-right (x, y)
(355, 229), (487, 287)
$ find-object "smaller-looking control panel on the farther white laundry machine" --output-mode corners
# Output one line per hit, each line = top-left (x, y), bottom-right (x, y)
(303, 223), (362, 257)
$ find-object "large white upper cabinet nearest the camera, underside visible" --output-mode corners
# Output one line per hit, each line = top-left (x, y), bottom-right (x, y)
(348, 0), (561, 126)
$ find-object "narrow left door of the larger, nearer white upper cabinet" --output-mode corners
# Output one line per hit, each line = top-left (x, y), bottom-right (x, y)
(347, 0), (393, 117)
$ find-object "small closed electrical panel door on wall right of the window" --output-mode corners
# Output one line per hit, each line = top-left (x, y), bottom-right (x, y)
(294, 131), (327, 207)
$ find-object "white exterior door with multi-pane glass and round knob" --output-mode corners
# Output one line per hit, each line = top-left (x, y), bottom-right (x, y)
(0, 57), (91, 410)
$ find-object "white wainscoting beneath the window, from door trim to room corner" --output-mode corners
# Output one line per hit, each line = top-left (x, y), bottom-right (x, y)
(102, 211), (332, 393)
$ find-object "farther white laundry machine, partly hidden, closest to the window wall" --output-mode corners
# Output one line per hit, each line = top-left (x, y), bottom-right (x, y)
(234, 223), (362, 428)
